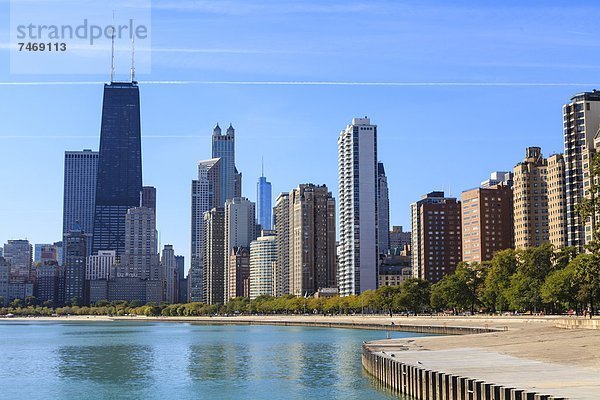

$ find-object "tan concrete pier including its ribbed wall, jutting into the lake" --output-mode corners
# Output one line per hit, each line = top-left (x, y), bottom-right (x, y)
(362, 319), (600, 400)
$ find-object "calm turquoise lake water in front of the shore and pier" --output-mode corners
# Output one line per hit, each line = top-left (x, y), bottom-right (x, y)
(0, 321), (417, 400)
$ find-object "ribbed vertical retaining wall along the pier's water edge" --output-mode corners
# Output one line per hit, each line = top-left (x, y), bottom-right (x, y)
(362, 343), (563, 400)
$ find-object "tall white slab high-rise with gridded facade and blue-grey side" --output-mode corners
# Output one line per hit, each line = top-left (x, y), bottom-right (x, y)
(338, 118), (379, 296)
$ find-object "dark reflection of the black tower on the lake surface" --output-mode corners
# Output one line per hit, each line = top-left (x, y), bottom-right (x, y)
(57, 344), (153, 384)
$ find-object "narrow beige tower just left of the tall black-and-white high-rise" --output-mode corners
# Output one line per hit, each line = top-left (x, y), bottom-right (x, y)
(547, 154), (568, 249)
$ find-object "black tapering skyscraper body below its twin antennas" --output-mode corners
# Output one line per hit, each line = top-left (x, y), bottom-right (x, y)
(92, 82), (142, 256)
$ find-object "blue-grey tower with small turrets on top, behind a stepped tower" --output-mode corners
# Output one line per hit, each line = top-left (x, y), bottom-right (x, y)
(212, 124), (241, 207)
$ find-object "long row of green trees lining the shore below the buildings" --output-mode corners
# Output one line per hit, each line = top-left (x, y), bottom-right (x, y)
(0, 244), (600, 318)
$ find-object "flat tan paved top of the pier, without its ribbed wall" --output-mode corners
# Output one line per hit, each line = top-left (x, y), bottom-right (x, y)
(370, 321), (600, 400)
